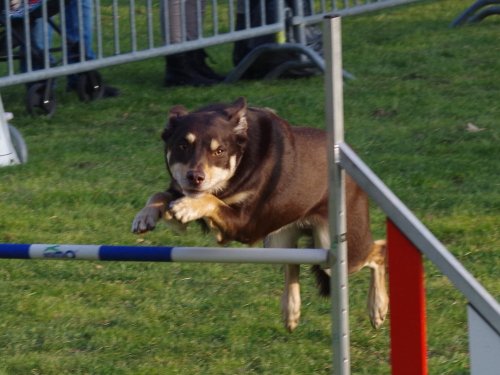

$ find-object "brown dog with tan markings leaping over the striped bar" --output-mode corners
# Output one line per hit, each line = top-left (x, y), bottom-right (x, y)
(132, 98), (388, 331)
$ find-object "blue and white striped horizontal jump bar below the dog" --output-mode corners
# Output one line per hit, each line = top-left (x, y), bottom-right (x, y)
(0, 244), (329, 264)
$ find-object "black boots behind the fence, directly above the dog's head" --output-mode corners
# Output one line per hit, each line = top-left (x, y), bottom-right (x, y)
(165, 52), (219, 86)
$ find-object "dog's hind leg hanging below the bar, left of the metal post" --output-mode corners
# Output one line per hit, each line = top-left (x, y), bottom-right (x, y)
(264, 224), (301, 332)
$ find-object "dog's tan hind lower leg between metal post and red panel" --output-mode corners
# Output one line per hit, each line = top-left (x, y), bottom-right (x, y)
(367, 240), (389, 328)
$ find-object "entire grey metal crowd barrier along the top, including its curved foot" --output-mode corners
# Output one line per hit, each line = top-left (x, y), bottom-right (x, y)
(0, 0), (422, 88)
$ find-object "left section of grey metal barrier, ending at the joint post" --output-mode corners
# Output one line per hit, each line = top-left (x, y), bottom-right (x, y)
(0, 0), (284, 87)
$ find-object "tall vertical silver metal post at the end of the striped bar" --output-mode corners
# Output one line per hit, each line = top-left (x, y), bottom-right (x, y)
(324, 16), (351, 375)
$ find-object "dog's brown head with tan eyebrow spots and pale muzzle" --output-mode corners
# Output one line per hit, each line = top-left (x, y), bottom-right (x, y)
(162, 98), (248, 195)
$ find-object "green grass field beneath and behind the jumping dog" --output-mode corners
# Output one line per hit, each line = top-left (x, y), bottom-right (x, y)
(0, 0), (500, 375)
